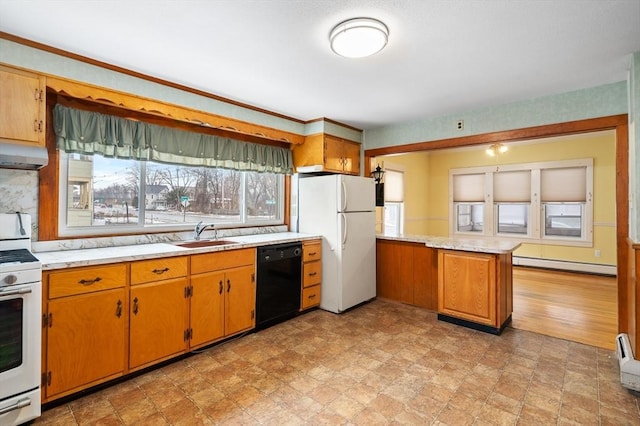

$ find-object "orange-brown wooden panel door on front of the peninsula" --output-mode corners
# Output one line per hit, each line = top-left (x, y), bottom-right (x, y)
(438, 250), (500, 327)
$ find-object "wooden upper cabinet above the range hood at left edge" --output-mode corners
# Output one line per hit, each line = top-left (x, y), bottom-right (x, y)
(0, 66), (46, 146)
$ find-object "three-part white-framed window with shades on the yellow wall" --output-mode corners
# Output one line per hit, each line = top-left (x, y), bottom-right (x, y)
(449, 158), (593, 246)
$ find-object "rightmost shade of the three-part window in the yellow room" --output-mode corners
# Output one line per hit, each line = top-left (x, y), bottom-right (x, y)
(540, 167), (587, 202)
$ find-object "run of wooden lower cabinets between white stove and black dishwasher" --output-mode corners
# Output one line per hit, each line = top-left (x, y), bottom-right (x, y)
(42, 248), (255, 403)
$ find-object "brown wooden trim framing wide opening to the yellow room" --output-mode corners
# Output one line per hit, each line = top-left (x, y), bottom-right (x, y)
(364, 114), (640, 346)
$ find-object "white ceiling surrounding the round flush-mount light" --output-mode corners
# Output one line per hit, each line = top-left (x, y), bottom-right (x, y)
(0, 0), (640, 129)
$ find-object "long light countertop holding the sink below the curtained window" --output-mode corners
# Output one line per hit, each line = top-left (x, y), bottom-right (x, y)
(34, 232), (320, 271)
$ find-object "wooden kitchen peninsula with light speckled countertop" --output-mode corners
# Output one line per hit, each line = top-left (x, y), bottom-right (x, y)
(376, 235), (520, 334)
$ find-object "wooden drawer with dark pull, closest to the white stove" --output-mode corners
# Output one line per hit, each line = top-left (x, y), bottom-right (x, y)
(49, 264), (127, 299)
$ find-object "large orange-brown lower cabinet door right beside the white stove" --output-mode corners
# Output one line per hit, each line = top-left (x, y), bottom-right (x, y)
(46, 288), (127, 398)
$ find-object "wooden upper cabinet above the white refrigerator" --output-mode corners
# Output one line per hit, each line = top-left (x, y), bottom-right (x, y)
(293, 133), (360, 175)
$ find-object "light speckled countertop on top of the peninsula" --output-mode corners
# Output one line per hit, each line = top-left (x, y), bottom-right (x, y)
(376, 234), (521, 254)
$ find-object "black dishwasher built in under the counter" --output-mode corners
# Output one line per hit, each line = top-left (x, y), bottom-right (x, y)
(256, 243), (302, 329)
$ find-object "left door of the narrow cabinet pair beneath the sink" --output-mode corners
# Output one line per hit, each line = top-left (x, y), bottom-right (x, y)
(190, 272), (226, 347)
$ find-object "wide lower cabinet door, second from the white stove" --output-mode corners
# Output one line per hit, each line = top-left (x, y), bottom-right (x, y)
(129, 278), (188, 368)
